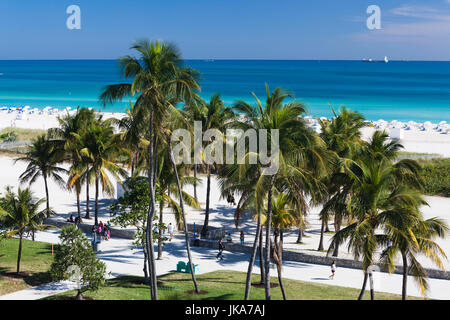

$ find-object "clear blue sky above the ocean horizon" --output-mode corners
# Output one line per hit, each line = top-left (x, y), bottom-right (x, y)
(0, 0), (450, 60)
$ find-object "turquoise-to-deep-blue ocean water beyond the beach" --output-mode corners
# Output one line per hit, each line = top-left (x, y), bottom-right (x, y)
(0, 60), (450, 122)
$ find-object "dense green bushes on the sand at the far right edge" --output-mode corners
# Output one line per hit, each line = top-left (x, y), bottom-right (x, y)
(419, 158), (450, 197)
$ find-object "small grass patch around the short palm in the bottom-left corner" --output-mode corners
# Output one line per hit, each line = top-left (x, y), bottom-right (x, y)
(0, 239), (53, 295)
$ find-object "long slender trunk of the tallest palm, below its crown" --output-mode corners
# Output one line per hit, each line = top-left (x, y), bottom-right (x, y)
(146, 110), (158, 300)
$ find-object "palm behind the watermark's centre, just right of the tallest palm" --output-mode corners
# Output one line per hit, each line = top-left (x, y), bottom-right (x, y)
(185, 93), (234, 237)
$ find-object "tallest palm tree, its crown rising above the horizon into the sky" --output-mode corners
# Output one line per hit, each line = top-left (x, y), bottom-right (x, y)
(100, 41), (199, 300)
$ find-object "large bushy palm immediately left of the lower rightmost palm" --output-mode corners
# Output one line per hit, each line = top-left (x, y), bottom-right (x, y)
(328, 153), (425, 299)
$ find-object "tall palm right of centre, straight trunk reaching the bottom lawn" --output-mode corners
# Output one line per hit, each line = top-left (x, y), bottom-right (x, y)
(233, 85), (306, 300)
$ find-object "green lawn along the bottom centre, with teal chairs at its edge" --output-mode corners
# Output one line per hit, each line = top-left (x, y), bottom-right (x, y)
(46, 271), (420, 300)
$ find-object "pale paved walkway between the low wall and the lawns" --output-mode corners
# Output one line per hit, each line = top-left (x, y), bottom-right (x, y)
(0, 231), (450, 300)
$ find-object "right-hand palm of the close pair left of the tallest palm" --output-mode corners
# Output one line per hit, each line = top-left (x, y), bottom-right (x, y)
(74, 119), (127, 224)
